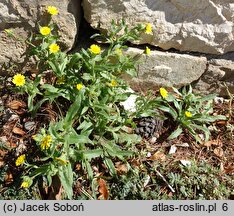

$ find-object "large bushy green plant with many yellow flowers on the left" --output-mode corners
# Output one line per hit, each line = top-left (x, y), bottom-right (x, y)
(9, 5), (153, 199)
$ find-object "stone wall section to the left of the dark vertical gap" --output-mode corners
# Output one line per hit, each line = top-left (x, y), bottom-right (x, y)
(0, 0), (80, 65)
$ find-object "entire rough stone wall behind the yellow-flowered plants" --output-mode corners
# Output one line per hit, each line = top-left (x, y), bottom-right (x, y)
(0, 0), (234, 95)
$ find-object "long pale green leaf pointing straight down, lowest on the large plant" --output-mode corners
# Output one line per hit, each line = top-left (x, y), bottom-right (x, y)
(58, 163), (73, 199)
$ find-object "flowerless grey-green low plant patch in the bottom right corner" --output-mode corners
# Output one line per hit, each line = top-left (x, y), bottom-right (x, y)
(167, 161), (233, 200)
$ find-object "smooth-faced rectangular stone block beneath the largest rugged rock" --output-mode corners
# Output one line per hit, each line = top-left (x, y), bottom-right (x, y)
(124, 48), (207, 91)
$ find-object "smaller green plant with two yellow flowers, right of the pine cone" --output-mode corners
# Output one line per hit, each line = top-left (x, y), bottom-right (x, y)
(155, 85), (226, 143)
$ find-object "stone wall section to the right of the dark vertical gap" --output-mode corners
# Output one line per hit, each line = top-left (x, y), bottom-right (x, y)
(83, 0), (234, 95)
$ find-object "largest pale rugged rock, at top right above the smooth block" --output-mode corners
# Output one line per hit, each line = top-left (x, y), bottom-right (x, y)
(83, 0), (234, 54)
